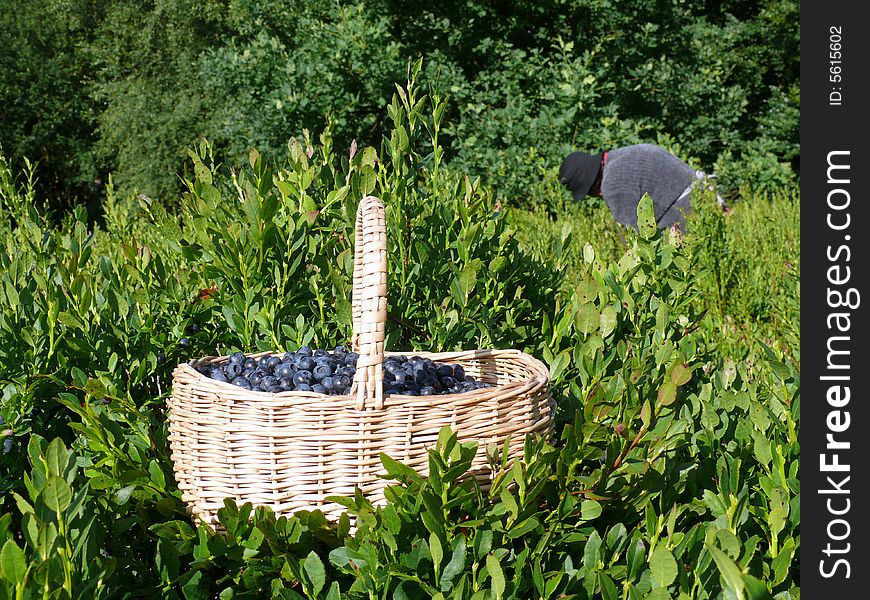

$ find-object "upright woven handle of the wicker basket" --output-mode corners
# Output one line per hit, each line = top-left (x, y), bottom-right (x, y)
(351, 196), (387, 410)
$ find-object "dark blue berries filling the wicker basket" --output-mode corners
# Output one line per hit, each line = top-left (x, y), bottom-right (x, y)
(197, 346), (492, 396)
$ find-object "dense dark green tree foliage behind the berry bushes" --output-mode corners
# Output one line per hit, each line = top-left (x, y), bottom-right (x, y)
(0, 0), (799, 211)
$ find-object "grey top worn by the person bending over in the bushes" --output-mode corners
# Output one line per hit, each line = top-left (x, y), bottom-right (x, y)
(601, 144), (695, 230)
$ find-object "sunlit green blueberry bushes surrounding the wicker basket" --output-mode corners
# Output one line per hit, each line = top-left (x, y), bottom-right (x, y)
(0, 71), (800, 600)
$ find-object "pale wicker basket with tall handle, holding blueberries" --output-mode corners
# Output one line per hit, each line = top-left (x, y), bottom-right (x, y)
(168, 196), (553, 525)
